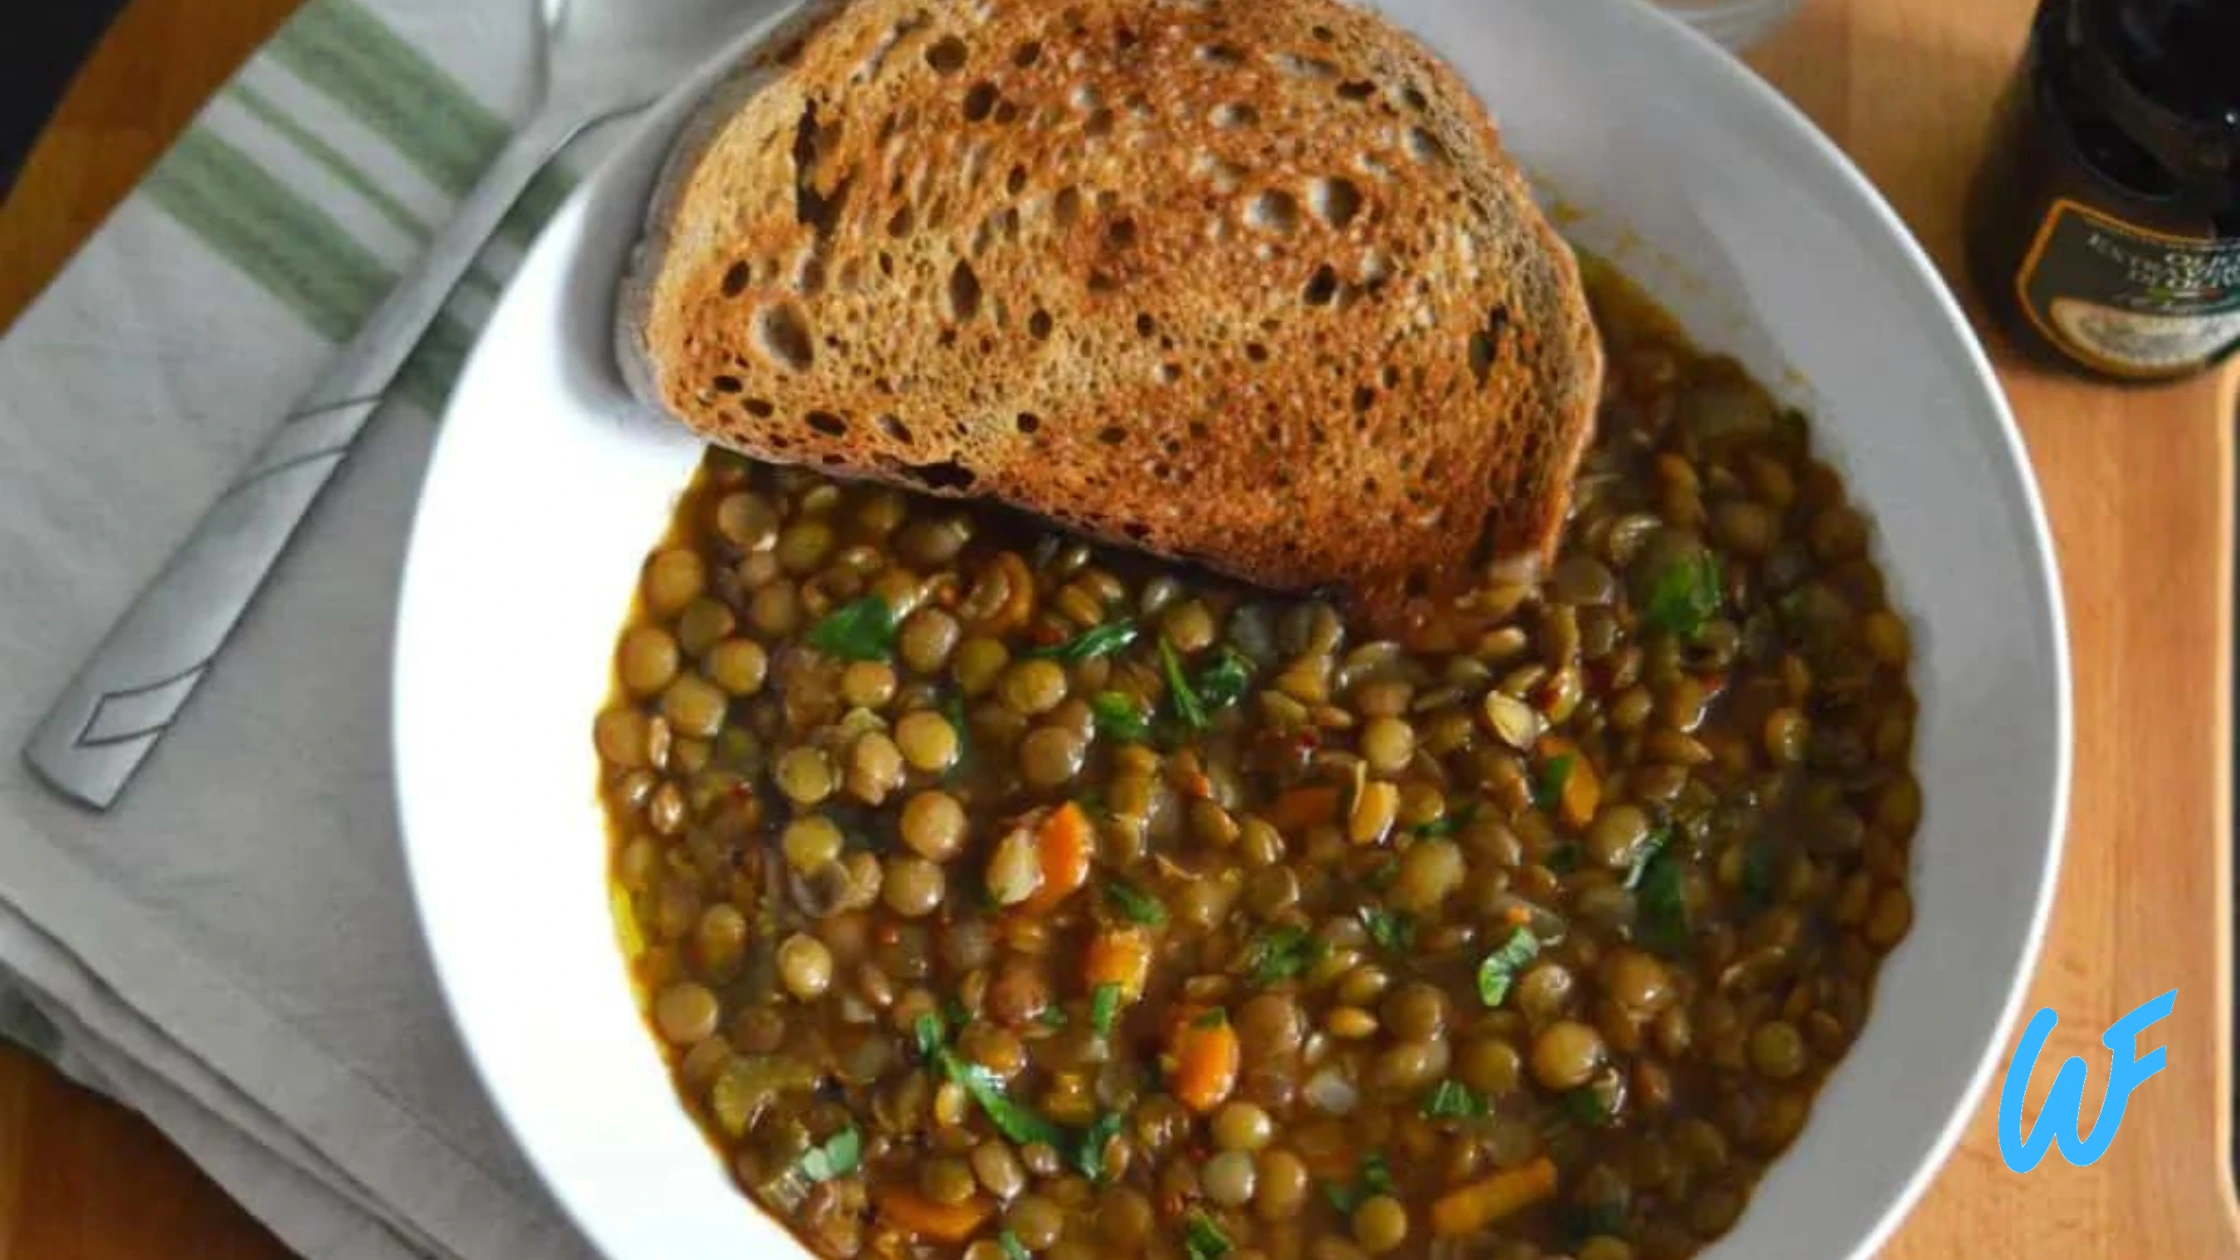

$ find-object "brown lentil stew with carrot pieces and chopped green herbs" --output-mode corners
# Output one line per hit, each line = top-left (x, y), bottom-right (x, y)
(594, 269), (1922, 1260)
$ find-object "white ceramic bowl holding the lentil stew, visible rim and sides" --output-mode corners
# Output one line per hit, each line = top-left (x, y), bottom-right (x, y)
(394, 0), (2070, 1260)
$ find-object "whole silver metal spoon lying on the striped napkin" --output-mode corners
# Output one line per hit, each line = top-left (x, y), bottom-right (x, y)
(25, 0), (771, 809)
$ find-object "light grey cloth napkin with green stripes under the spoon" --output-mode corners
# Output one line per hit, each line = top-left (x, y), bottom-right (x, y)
(0, 0), (631, 1260)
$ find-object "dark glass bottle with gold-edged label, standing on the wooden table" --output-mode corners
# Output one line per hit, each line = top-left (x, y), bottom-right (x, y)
(1967, 0), (2240, 381)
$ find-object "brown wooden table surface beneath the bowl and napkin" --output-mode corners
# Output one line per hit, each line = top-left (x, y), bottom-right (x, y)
(0, 0), (2240, 1260)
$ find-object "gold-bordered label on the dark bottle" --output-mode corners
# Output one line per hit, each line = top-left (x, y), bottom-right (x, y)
(2016, 197), (2240, 377)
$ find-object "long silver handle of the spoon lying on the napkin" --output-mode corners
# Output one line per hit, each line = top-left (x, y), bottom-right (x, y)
(25, 112), (582, 809)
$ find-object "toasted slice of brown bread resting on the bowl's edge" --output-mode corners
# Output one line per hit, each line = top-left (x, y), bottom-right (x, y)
(618, 0), (1602, 628)
